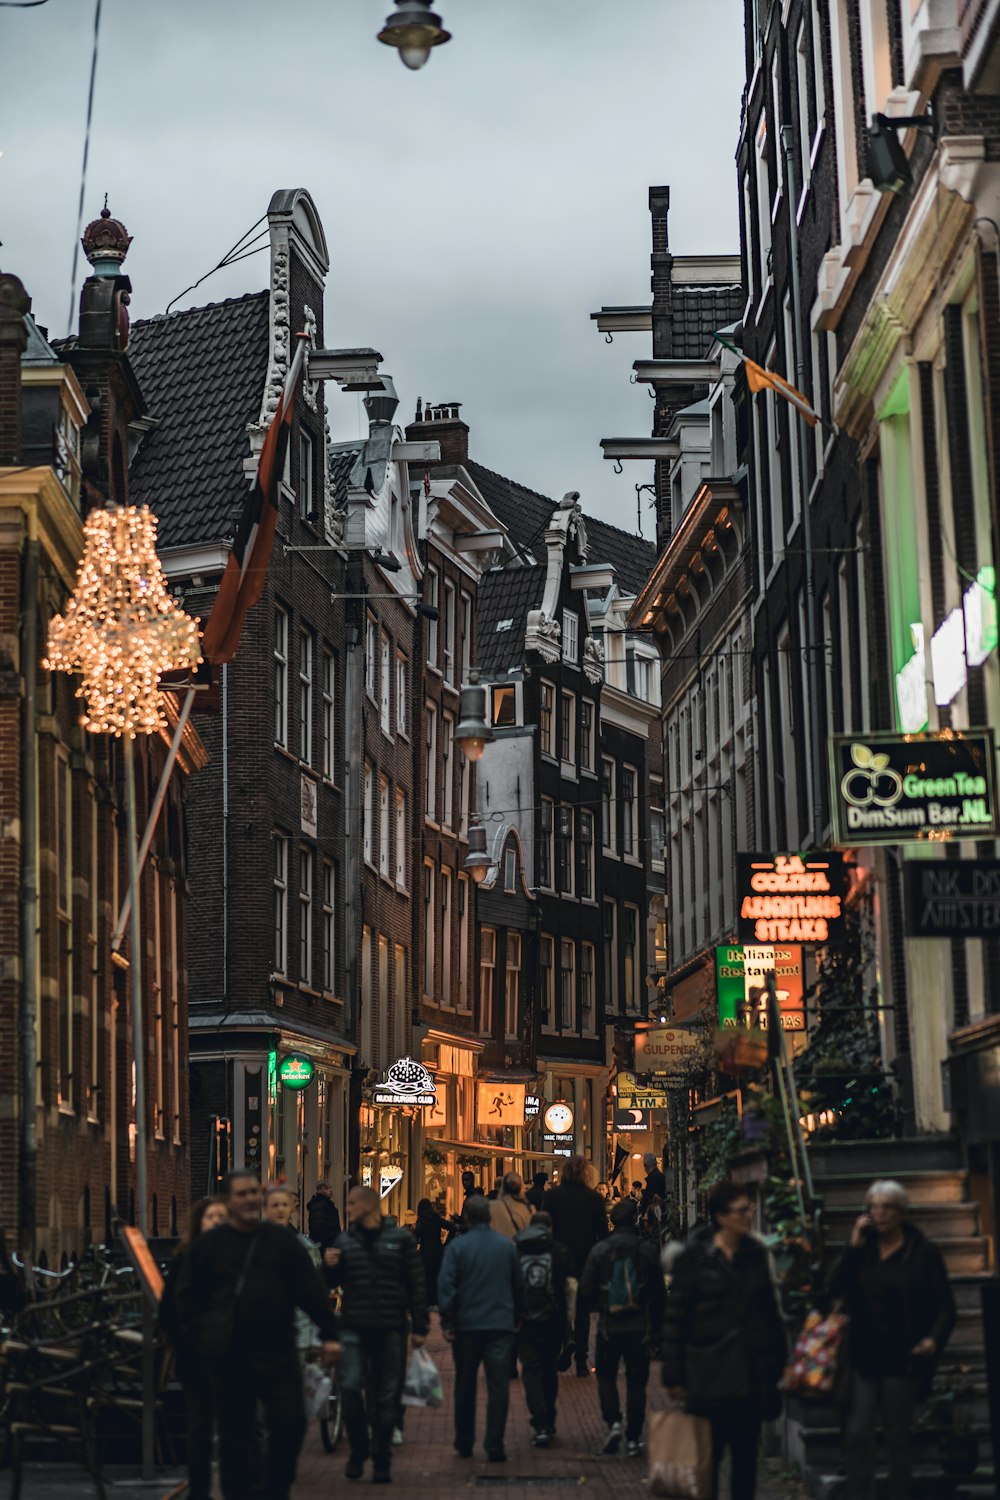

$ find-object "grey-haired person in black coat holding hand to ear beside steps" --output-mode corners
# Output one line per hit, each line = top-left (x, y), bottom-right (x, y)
(828, 1182), (955, 1500)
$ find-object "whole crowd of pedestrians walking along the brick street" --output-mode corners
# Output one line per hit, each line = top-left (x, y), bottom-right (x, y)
(162, 1157), (955, 1500)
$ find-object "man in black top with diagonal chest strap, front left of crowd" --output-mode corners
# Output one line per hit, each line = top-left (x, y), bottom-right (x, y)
(175, 1172), (337, 1500)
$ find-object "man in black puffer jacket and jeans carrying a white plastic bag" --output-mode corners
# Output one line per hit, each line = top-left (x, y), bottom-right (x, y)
(328, 1187), (430, 1485)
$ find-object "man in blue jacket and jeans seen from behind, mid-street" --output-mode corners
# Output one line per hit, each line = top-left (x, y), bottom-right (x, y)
(438, 1197), (523, 1464)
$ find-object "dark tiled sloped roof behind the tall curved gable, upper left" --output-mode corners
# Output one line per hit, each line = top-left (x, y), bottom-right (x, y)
(129, 291), (268, 548)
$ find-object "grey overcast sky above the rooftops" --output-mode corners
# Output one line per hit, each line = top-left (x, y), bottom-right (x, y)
(0, 0), (744, 537)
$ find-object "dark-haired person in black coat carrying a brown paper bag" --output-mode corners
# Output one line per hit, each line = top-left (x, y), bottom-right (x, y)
(663, 1182), (786, 1500)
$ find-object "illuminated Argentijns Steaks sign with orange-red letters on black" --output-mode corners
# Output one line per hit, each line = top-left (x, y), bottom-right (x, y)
(736, 851), (847, 945)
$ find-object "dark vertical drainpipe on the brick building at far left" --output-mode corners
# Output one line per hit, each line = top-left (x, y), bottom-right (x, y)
(18, 518), (39, 1260)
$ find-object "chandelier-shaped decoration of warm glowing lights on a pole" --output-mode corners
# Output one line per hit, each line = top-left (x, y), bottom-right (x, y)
(42, 506), (201, 740)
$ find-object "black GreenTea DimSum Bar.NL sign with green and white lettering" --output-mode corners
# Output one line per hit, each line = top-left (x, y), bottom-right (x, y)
(831, 729), (999, 845)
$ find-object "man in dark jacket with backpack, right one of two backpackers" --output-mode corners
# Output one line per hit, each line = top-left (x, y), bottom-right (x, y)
(580, 1199), (664, 1458)
